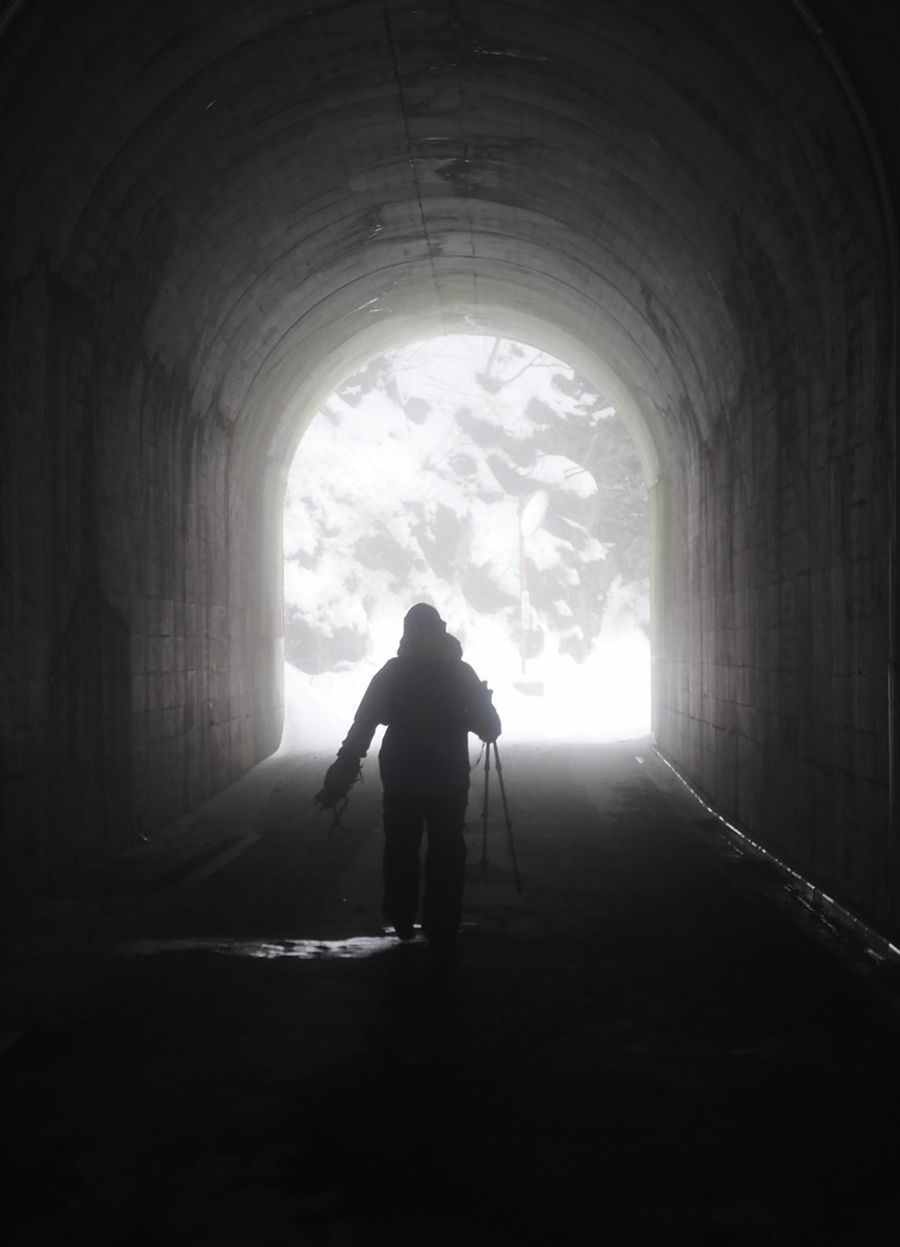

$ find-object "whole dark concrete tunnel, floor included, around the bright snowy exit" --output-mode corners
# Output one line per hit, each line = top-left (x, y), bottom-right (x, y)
(0, 0), (900, 1247)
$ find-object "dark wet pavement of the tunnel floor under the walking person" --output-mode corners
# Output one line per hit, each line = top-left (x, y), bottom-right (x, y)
(0, 741), (900, 1247)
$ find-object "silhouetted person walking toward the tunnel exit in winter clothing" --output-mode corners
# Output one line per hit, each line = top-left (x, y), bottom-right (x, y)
(315, 602), (500, 964)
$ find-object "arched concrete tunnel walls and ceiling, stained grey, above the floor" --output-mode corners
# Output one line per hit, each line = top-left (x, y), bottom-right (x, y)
(0, 0), (900, 932)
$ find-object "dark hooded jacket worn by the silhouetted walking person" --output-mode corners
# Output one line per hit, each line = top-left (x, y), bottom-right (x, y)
(338, 630), (500, 797)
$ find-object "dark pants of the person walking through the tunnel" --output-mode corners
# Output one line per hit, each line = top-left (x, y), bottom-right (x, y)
(384, 789), (469, 941)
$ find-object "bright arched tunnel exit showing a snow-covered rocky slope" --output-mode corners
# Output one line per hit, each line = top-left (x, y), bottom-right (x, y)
(276, 335), (649, 751)
